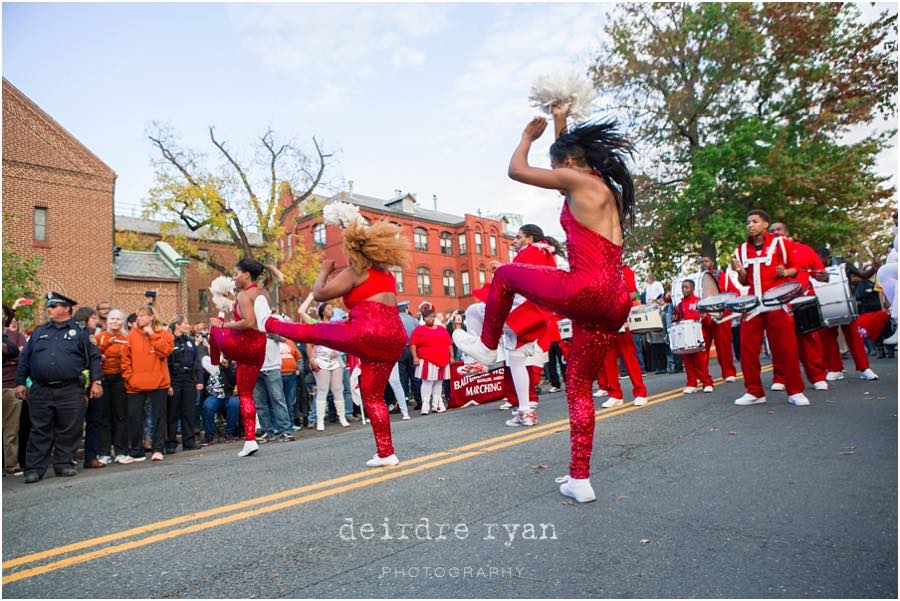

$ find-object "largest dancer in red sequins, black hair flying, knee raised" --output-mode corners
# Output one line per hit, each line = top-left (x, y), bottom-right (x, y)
(455, 105), (634, 502)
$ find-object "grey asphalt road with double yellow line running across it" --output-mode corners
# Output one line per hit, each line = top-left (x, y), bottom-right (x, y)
(2, 360), (898, 598)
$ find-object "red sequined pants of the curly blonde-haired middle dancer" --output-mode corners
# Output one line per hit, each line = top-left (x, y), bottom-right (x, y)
(266, 301), (406, 457)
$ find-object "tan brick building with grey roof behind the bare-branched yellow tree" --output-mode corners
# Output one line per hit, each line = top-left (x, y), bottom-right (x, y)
(116, 215), (262, 323)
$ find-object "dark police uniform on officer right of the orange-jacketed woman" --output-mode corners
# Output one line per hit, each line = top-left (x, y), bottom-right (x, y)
(166, 334), (203, 453)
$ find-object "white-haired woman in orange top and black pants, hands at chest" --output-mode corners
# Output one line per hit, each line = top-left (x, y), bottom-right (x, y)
(94, 309), (130, 463)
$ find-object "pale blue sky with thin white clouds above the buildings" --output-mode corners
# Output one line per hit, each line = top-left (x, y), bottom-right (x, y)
(2, 3), (896, 241)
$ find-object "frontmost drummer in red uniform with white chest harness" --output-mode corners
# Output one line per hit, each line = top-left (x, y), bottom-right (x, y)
(731, 209), (809, 406)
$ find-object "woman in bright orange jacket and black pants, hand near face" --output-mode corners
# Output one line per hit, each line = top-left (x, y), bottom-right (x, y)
(120, 305), (175, 463)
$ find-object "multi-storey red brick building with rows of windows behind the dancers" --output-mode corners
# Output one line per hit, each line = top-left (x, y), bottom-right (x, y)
(280, 190), (515, 315)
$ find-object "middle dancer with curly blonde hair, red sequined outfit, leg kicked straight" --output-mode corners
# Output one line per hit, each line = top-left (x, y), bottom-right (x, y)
(264, 220), (407, 467)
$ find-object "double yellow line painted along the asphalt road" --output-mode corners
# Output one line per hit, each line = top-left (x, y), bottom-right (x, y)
(2, 366), (771, 584)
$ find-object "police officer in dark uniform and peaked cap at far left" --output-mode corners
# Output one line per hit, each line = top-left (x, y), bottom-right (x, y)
(16, 292), (103, 483)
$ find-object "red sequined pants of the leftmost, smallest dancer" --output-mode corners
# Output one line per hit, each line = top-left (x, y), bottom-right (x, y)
(209, 326), (266, 440)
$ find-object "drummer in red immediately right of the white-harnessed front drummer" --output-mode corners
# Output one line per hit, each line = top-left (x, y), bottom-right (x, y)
(769, 222), (828, 390)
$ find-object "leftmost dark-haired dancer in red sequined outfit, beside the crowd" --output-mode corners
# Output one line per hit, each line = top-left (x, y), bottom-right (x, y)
(209, 258), (269, 457)
